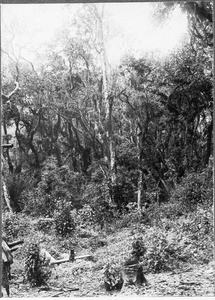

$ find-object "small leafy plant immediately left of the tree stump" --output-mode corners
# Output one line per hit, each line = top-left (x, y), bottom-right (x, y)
(104, 264), (123, 291)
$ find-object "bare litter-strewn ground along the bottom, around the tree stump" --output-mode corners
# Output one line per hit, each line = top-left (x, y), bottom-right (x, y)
(7, 260), (215, 298)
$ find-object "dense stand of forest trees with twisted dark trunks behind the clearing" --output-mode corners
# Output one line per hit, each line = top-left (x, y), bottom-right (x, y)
(1, 2), (213, 210)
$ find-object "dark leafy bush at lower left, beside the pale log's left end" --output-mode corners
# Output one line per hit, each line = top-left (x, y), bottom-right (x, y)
(25, 243), (51, 286)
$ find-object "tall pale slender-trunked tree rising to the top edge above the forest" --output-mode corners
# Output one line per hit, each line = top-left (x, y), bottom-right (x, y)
(78, 4), (116, 201)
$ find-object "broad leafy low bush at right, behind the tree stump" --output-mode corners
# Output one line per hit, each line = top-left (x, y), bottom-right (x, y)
(136, 206), (214, 273)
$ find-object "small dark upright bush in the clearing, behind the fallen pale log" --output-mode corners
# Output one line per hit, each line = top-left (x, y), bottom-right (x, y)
(54, 205), (76, 237)
